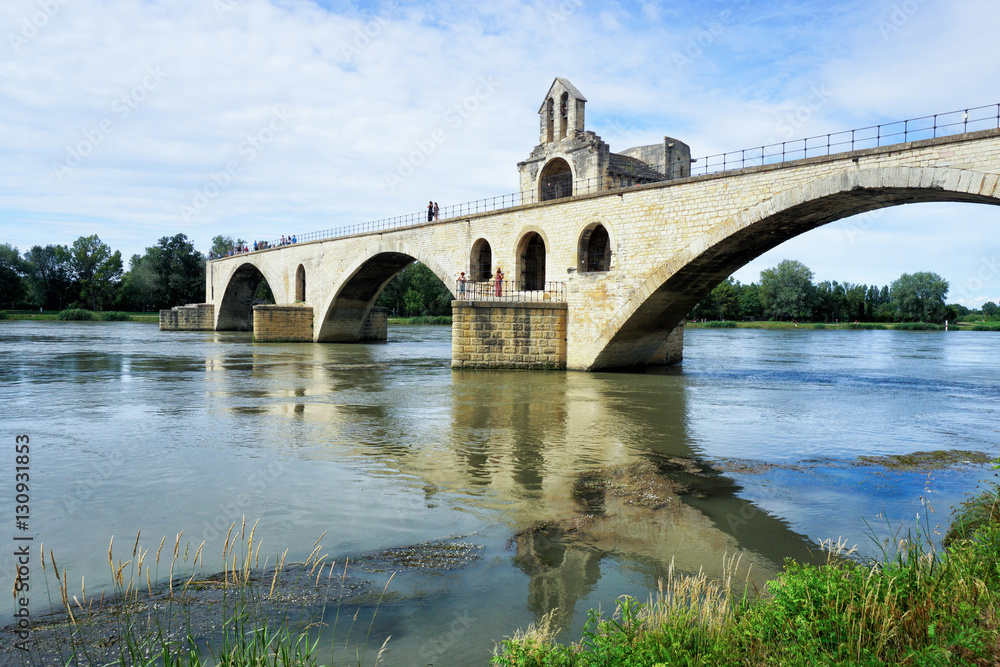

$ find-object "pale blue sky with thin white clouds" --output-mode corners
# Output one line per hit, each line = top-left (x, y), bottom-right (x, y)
(0, 0), (1000, 307)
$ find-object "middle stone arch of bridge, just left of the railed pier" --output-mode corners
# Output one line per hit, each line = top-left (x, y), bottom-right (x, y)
(313, 241), (455, 342)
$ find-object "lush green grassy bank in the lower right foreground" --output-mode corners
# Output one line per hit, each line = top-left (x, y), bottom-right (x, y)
(493, 485), (1000, 667)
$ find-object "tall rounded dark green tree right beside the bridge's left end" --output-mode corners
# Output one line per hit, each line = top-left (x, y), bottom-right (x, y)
(144, 234), (205, 308)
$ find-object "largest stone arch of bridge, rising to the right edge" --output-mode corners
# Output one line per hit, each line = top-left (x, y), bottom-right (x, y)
(589, 167), (1000, 369)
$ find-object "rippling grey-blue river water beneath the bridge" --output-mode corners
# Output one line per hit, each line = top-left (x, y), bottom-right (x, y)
(0, 321), (1000, 665)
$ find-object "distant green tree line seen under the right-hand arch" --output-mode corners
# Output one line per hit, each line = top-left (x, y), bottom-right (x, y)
(689, 259), (1000, 323)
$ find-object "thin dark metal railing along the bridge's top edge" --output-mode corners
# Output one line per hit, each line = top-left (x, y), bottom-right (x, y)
(209, 103), (1000, 260)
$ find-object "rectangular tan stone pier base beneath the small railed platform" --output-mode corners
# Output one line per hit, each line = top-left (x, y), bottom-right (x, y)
(451, 301), (568, 369)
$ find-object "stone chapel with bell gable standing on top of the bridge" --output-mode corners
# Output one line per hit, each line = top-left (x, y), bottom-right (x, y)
(517, 78), (691, 203)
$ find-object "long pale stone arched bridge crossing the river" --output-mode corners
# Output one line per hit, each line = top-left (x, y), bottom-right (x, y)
(193, 126), (1000, 370)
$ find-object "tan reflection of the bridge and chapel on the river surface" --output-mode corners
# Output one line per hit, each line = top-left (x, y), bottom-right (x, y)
(201, 334), (818, 624)
